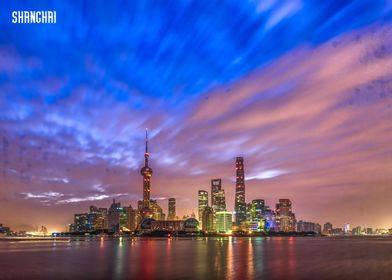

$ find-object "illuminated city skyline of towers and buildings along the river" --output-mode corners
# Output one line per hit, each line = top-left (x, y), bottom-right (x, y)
(1, 128), (387, 235)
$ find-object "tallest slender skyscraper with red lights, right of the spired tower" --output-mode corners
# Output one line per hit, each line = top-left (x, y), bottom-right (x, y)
(234, 157), (246, 226)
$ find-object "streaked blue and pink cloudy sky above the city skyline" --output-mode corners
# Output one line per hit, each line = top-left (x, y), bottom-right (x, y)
(0, 0), (392, 231)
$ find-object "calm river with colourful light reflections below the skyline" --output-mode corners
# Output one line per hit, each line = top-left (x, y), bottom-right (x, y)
(0, 237), (392, 279)
